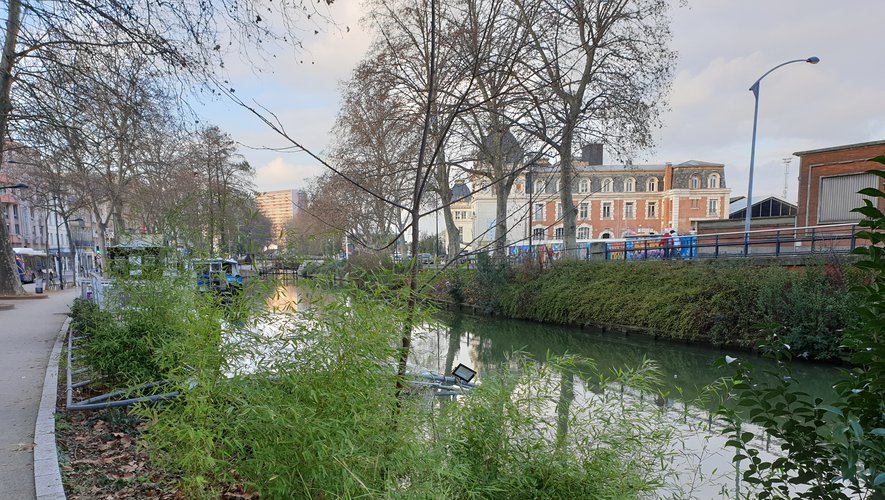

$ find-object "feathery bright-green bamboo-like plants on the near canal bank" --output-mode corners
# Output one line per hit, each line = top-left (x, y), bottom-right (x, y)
(67, 278), (671, 498)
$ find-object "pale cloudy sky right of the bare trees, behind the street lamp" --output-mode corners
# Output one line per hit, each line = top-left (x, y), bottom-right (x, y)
(650, 0), (885, 200)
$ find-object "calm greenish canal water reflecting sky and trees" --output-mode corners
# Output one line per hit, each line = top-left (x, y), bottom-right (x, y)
(268, 285), (839, 498)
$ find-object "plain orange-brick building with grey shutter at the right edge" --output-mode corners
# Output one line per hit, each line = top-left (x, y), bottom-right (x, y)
(793, 140), (885, 227)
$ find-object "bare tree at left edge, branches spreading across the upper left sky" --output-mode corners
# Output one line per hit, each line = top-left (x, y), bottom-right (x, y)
(0, 0), (331, 293)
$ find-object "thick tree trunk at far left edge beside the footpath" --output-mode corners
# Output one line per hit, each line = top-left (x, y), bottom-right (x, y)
(0, 0), (25, 295)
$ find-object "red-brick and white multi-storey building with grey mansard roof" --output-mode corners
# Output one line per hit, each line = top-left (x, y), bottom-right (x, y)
(452, 148), (730, 250)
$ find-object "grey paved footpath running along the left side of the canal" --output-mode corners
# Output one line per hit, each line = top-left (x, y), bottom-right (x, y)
(0, 285), (77, 500)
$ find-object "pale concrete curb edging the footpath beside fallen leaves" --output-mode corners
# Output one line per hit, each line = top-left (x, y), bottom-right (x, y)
(34, 318), (71, 500)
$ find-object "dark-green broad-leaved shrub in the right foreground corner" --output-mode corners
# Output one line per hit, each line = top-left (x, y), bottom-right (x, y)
(719, 160), (885, 498)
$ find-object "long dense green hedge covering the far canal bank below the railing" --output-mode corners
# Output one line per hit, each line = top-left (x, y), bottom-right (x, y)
(436, 259), (862, 359)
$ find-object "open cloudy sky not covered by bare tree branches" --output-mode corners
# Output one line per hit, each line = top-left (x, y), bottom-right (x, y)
(196, 0), (885, 202)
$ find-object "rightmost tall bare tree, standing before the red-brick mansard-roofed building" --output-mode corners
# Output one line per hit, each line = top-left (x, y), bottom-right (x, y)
(516, 0), (675, 257)
